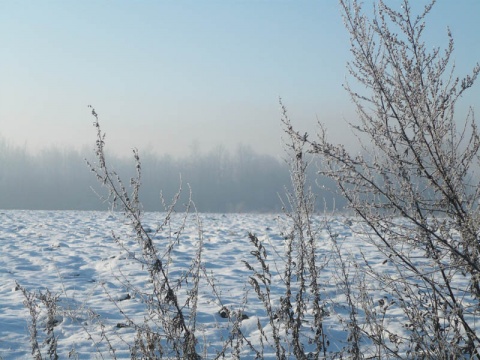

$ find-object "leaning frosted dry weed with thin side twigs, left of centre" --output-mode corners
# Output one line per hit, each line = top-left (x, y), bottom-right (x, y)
(87, 109), (203, 359)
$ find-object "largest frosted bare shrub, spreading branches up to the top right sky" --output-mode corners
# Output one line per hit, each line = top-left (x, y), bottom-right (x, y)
(289, 0), (480, 359)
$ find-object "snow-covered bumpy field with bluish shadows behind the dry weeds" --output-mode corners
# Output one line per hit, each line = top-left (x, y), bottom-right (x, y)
(0, 211), (476, 359)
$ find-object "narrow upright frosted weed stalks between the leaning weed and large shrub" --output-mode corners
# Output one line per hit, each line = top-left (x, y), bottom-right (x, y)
(245, 108), (329, 359)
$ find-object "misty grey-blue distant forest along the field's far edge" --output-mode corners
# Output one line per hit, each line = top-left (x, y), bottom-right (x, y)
(0, 138), (339, 212)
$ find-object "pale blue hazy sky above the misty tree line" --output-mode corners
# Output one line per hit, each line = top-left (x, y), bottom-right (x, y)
(0, 0), (480, 155)
